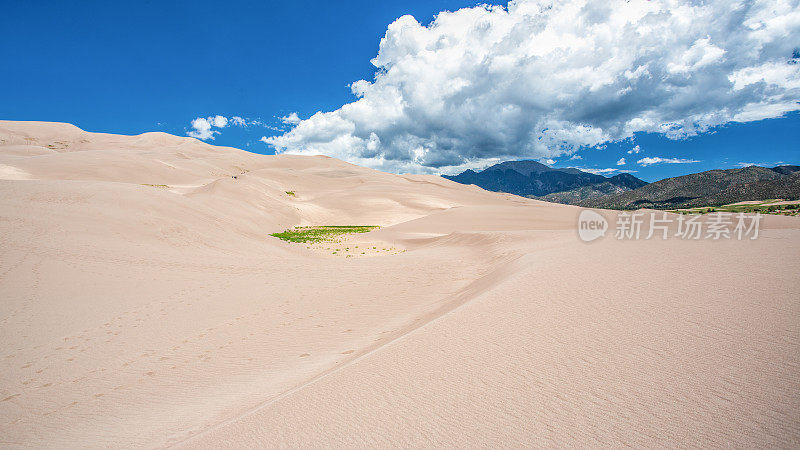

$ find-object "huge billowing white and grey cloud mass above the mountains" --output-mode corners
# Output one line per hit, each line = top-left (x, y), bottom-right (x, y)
(266, 0), (800, 172)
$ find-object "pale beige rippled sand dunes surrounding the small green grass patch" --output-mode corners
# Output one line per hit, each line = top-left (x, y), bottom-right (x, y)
(0, 121), (800, 448)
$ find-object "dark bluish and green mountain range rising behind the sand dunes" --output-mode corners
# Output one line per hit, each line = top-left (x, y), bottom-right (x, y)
(445, 161), (800, 209)
